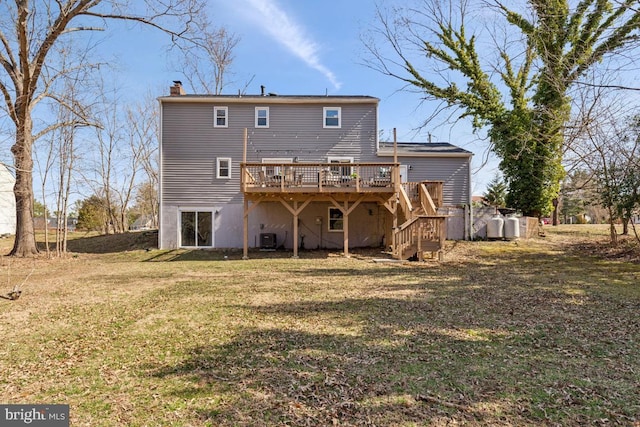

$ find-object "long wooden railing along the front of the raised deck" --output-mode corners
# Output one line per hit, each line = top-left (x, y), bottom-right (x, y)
(240, 163), (398, 192)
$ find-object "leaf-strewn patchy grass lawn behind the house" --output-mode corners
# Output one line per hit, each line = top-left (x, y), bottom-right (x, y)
(0, 226), (640, 426)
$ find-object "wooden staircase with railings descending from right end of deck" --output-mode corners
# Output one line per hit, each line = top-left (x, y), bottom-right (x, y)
(393, 181), (447, 261)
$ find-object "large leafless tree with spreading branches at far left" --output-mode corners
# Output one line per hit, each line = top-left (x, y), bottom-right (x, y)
(0, 0), (205, 256)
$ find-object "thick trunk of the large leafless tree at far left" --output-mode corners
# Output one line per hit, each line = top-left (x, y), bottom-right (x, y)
(9, 117), (38, 257)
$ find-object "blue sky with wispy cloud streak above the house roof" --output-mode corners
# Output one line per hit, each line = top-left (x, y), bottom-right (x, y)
(109, 0), (496, 194)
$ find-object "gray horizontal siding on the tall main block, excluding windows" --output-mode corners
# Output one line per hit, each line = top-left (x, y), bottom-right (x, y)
(162, 99), (377, 204)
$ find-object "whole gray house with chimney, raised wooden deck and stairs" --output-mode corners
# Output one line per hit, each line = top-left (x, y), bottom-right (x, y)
(158, 82), (471, 258)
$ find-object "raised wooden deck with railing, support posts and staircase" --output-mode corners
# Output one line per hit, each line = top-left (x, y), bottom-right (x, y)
(240, 162), (446, 260)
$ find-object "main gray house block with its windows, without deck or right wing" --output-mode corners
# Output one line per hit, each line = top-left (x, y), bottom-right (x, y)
(159, 84), (382, 248)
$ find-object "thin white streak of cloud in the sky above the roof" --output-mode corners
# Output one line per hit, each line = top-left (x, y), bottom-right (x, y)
(242, 0), (341, 89)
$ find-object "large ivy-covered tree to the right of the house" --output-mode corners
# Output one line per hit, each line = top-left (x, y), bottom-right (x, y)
(366, 0), (640, 216)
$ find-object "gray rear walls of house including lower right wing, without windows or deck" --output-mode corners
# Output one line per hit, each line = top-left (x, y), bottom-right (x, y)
(160, 96), (471, 248)
